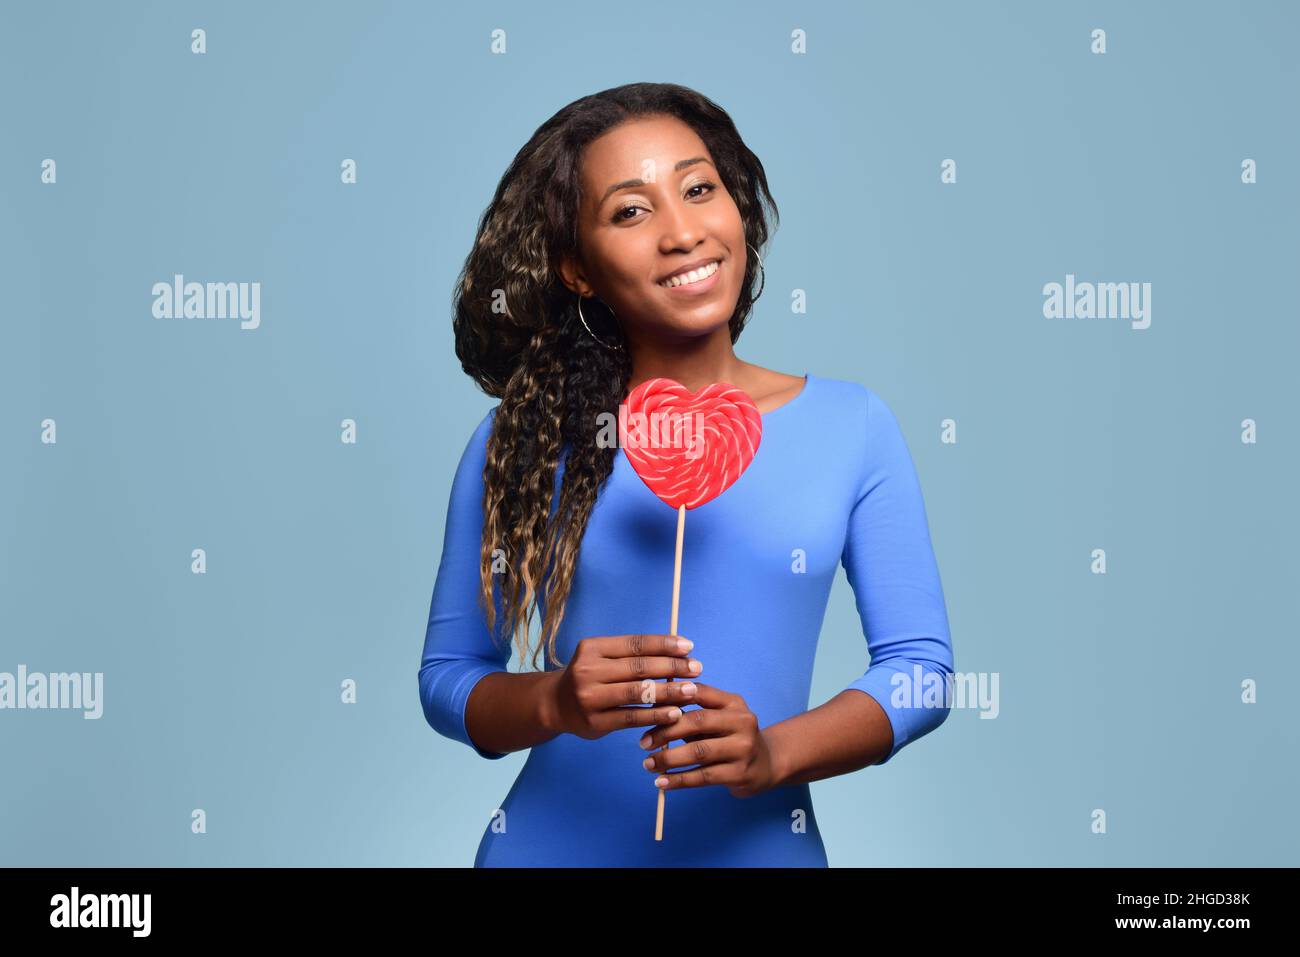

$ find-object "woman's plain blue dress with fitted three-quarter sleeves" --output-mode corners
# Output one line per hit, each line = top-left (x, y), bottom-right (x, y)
(420, 374), (953, 867)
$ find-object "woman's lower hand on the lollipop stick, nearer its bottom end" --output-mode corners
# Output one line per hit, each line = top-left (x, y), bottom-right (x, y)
(641, 680), (776, 797)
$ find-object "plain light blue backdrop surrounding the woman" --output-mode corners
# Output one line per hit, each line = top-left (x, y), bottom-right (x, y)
(0, 3), (1300, 866)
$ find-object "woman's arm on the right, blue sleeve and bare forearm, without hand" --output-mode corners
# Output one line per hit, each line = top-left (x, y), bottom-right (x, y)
(763, 391), (953, 785)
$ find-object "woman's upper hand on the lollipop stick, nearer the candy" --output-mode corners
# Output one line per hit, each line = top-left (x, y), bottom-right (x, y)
(551, 635), (703, 740)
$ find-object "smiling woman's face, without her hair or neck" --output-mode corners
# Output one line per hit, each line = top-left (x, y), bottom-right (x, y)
(559, 117), (748, 342)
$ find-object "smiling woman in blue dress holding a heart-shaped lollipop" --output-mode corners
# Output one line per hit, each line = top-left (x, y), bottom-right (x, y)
(420, 83), (953, 867)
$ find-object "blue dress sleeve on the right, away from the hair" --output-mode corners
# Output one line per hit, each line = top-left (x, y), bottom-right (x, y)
(841, 389), (953, 765)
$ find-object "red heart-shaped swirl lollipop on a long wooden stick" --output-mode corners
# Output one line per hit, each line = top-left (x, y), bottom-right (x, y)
(619, 378), (763, 841)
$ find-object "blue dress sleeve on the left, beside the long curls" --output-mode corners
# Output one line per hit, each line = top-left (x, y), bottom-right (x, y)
(420, 407), (510, 759)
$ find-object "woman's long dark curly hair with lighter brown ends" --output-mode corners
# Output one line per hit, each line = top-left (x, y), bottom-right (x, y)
(452, 83), (779, 668)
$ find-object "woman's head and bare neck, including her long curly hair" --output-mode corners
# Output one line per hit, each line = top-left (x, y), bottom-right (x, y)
(454, 83), (774, 681)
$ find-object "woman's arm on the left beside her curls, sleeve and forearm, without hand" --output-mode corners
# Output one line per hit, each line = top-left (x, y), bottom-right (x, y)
(420, 408), (556, 759)
